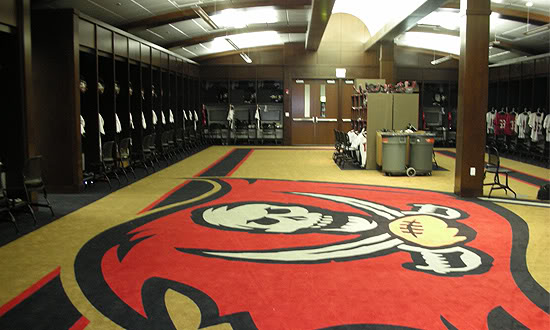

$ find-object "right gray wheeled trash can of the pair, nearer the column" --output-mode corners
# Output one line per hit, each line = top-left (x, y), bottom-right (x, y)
(407, 134), (435, 176)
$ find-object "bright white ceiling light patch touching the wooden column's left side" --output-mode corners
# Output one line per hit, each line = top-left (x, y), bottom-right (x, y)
(395, 32), (460, 55)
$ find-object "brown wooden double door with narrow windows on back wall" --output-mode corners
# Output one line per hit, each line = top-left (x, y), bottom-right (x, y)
(291, 79), (353, 145)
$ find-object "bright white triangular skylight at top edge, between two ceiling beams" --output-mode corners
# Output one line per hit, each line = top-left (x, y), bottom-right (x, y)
(332, 0), (426, 36)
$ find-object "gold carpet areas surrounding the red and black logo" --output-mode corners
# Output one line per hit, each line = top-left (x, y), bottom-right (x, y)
(0, 146), (550, 330)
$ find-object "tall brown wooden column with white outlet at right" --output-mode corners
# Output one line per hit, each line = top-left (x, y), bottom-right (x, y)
(454, 0), (491, 197)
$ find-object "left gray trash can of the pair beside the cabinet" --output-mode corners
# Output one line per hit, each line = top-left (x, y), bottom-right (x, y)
(382, 133), (407, 175)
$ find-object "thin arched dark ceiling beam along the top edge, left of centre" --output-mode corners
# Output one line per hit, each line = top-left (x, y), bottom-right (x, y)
(119, 0), (311, 31)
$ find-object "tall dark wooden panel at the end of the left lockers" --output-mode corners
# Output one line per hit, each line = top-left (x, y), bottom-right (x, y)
(31, 10), (82, 191)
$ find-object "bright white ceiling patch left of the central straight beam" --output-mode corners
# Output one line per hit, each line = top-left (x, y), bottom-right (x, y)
(211, 8), (279, 29)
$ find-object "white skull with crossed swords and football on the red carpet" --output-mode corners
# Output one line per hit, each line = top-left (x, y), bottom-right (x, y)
(188, 192), (491, 276)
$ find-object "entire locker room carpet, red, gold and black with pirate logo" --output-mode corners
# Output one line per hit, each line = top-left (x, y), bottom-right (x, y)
(0, 147), (550, 329)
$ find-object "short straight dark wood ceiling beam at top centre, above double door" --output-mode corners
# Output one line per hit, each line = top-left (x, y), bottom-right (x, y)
(306, 0), (335, 51)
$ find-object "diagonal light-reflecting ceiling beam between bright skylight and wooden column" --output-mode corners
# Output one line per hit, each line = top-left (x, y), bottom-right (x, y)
(365, 0), (448, 51)
